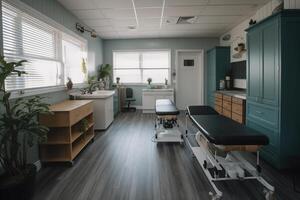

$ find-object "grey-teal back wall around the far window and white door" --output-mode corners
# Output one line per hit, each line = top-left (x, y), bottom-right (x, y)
(103, 38), (219, 106)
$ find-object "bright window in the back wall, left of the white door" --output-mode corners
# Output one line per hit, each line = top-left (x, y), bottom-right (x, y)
(113, 50), (170, 83)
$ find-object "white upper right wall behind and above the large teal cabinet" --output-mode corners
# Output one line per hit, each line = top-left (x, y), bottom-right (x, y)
(220, 0), (282, 62)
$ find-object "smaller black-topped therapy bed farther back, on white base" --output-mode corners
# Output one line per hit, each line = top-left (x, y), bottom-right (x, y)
(154, 99), (183, 143)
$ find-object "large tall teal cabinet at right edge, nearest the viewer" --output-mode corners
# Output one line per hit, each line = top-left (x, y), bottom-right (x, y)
(246, 10), (300, 168)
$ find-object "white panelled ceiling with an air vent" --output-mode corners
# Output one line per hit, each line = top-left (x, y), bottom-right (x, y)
(58, 0), (269, 39)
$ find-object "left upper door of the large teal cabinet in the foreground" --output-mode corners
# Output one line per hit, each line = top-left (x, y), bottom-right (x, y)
(247, 29), (261, 102)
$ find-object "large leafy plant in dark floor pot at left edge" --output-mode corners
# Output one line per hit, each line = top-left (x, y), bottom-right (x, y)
(0, 56), (50, 200)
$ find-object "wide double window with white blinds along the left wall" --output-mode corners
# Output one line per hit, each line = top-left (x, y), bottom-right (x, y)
(2, 2), (86, 91)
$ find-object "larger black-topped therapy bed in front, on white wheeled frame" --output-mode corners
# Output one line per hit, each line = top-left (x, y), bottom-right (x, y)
(186, 106), (275, 199)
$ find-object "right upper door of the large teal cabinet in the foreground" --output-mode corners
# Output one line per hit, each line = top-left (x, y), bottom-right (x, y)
(261, 18), (279, 106)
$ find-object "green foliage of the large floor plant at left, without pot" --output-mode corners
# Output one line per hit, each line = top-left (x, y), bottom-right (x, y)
(0, 56), (50, 177)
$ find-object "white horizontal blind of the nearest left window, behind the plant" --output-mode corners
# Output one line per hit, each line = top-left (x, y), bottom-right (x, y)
(2, 2), (63, 90)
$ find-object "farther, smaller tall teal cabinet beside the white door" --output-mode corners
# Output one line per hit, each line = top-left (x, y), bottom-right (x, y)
(207, 47), (230, 107)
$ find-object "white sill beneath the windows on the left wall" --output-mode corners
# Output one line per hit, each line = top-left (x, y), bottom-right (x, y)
(10, 83), (86, 99)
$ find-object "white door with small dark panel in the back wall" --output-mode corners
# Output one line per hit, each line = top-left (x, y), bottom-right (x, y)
(175, 51), (204, 110)
